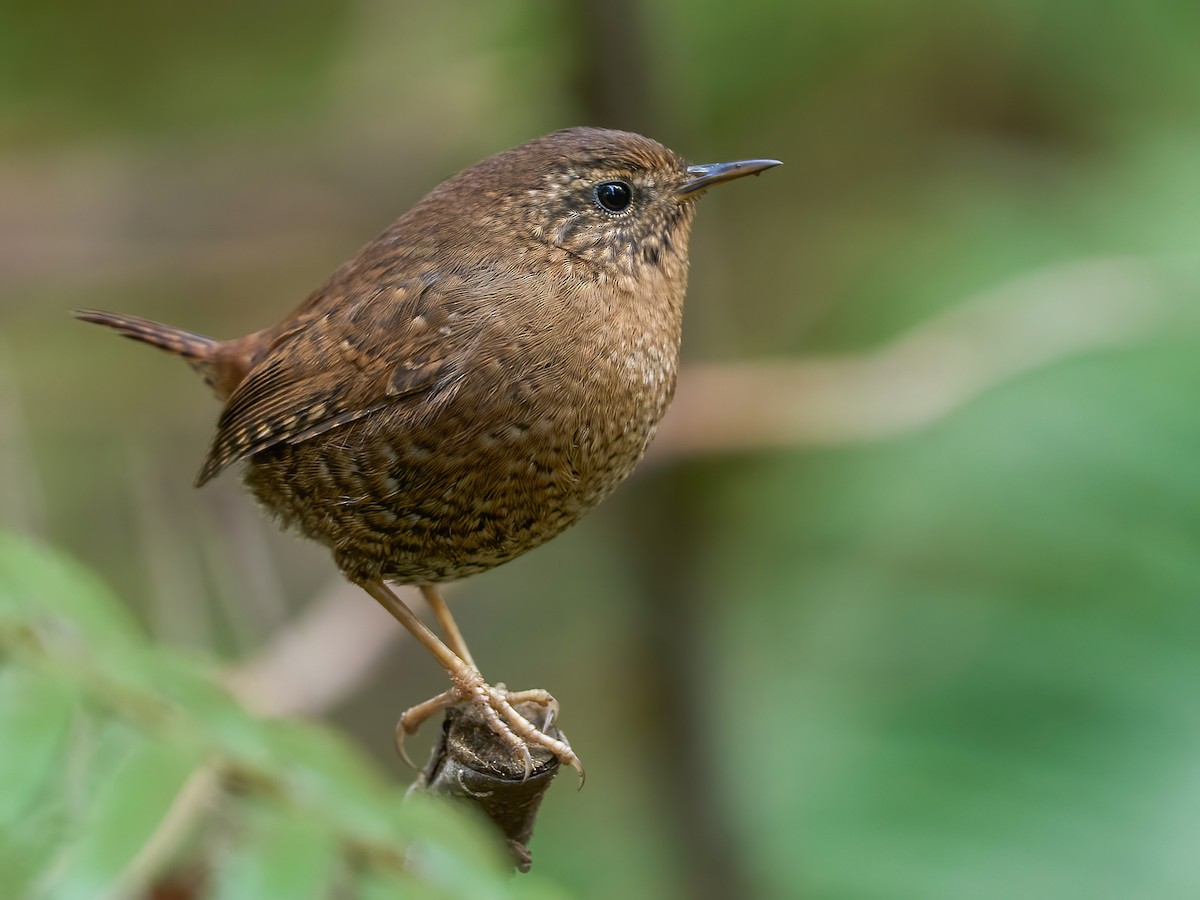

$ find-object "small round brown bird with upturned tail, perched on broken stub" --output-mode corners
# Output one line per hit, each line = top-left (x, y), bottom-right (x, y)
(77, 128), (779, 774)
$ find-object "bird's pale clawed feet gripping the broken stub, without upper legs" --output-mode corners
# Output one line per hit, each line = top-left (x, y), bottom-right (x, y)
(396, 665), (583, 786)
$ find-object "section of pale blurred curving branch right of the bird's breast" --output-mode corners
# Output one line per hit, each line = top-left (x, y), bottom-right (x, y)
(648, 259), (1166, 463)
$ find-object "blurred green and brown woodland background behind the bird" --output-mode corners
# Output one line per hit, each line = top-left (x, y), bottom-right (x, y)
(0, 0), (1200, 900)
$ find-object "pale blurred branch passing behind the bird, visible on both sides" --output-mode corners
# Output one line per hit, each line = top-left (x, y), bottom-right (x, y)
(218, 259), (1166, 714)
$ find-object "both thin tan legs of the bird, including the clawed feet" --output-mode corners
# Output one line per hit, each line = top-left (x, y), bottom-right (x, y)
(361, 578), (583, 779)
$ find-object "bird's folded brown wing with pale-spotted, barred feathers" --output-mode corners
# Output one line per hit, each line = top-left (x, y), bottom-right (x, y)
(196, 275), (478, 486)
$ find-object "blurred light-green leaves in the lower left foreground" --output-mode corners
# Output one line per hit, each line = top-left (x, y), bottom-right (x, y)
(0, 533), (561, 900)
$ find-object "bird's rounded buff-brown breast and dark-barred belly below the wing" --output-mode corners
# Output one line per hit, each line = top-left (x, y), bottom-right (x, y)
(247, 274), (678, 582)
